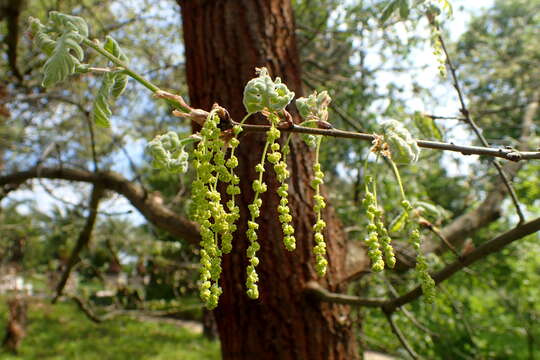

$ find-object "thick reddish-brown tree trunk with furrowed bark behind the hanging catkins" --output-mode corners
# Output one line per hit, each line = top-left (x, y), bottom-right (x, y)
(178, 0), (358, 360)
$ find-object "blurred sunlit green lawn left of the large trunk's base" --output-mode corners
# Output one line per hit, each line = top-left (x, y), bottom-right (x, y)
(0, 298), (220, 360)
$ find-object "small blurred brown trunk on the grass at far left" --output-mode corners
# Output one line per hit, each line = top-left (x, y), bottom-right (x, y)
(2, 296), (28, 354)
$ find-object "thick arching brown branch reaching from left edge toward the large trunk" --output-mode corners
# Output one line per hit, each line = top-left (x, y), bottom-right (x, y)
(0, 167), (200, 243)
